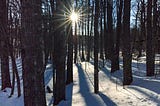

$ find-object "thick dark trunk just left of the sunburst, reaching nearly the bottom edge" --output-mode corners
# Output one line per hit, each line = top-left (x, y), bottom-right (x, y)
(53, 0), (66, 105)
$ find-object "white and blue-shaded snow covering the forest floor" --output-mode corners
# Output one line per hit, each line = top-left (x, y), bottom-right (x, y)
(0, 56), (160, 106)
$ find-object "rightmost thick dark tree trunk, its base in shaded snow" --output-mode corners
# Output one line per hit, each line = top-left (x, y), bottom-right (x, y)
(146, 0), (154, 76)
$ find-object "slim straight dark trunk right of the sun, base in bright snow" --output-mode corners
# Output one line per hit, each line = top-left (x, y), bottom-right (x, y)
(94, 0), (99, 93)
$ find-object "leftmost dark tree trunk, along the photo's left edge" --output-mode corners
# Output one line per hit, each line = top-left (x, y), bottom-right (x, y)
(0, 0), (11, 90)
